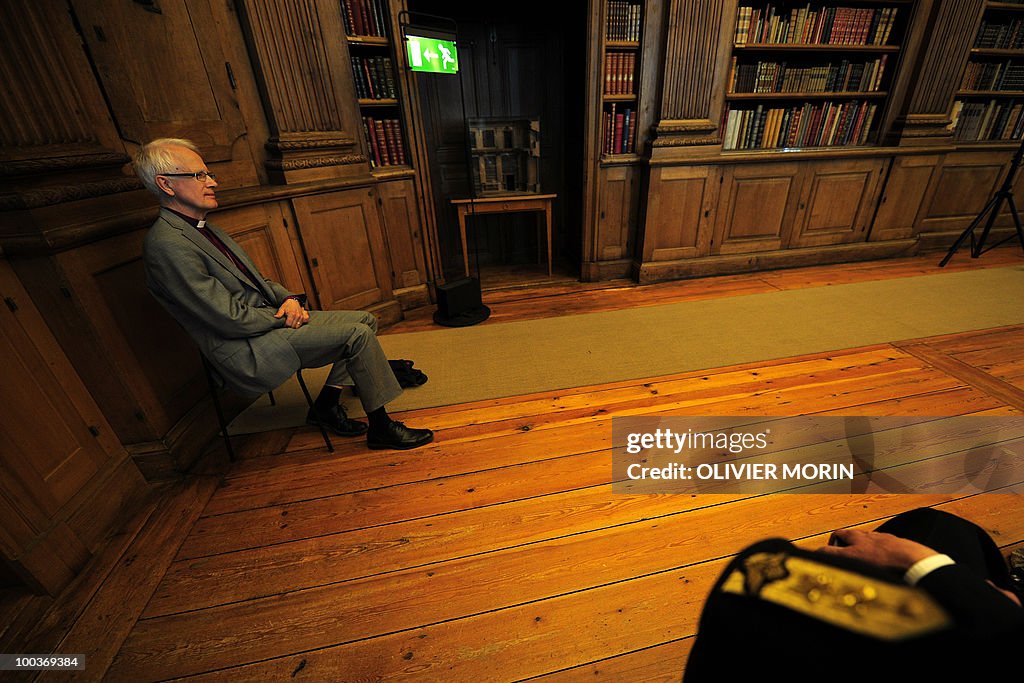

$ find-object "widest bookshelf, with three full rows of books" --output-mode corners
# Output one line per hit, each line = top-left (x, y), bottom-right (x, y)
(722, 0), (913, 152)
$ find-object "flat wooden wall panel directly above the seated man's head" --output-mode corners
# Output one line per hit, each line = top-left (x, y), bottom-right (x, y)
(71, 0), (259, 189)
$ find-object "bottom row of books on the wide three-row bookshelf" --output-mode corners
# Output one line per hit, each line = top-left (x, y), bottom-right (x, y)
(723, 100), (878, 150)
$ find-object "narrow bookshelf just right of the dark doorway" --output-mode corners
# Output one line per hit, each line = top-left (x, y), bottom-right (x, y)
(601, 0), (643, 157)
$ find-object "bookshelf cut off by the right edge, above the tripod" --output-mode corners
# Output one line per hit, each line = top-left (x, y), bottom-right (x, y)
(951, 0), (1024, 142)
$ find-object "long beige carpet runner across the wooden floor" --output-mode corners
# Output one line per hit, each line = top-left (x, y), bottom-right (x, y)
(230, 266), (1024, 433)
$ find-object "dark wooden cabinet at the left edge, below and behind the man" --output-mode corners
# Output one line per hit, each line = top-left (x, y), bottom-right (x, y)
(0, 260), (145, 594)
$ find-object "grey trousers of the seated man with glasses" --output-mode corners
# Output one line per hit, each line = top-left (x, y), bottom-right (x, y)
(279, 310), (401, 413)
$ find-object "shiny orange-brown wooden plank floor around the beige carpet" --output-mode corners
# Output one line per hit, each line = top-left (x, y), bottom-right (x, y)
(0, 249), (1024, 682)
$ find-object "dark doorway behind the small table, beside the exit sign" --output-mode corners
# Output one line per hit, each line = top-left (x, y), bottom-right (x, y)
(409, 0), (587, 289)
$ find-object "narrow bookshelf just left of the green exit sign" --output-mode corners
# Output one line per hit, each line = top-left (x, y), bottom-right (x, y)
(341, 0), (409, 171)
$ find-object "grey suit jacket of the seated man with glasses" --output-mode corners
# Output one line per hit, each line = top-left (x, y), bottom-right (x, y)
(142, 209), (300, 394)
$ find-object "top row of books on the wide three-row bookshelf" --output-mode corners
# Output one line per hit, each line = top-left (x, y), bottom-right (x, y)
(735, 3), (898, 46)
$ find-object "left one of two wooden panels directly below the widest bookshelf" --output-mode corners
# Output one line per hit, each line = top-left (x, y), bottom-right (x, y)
(711, 163), (802, 254)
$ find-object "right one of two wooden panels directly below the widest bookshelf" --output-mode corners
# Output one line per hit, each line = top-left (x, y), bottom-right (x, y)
(786, 159), (887, 247)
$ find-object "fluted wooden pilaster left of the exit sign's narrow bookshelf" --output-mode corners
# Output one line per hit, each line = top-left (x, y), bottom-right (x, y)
(238, 0), (370, 183)
